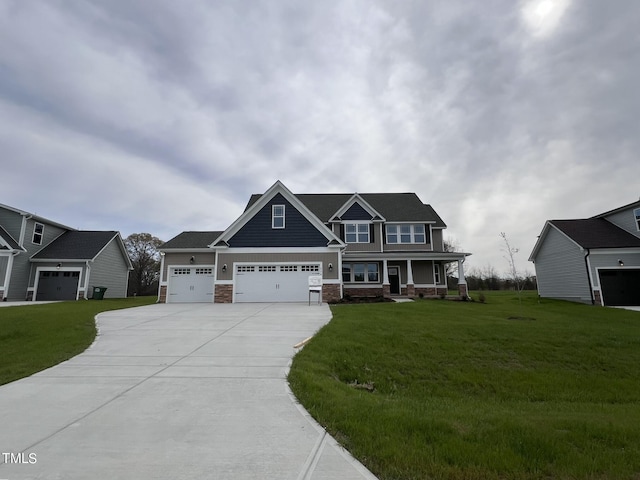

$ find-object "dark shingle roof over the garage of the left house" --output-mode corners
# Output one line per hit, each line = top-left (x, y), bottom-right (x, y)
(33, 230), (118, 260)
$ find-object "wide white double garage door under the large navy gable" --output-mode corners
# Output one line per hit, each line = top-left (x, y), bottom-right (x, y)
(235, 263), (320, 302)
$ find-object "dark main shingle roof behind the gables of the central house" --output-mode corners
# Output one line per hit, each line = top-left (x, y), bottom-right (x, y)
(245, 193), (446, 228)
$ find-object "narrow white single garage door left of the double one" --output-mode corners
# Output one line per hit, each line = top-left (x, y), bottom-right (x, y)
(167, 266), (214, 303)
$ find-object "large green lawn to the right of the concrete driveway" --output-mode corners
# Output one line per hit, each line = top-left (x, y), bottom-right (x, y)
(289, 292), (640, 479)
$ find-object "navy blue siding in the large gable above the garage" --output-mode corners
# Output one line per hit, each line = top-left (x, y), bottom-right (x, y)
(228, 194), (328, 247)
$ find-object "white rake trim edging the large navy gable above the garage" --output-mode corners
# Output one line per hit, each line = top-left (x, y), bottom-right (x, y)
(212, 180), (344, 246)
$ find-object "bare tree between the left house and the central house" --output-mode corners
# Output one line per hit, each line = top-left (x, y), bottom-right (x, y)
(124, 233), (164, 295)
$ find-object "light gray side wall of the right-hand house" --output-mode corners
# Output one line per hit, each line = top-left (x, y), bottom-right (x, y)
(535, 227), (591, 303)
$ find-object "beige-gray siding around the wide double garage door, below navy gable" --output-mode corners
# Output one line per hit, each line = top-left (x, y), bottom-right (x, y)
(216, 252), (340, 280)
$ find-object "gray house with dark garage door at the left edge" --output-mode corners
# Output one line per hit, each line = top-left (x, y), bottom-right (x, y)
(0, 204), (132, 301)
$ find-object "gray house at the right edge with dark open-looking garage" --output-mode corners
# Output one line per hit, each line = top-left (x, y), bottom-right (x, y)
(529, 201), (640, 305)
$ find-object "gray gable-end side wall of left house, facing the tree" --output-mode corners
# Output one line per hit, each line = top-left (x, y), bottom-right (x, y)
(86, 239), (129, 298)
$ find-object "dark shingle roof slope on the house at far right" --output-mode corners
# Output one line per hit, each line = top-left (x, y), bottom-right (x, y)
(550, 218), (640, 248)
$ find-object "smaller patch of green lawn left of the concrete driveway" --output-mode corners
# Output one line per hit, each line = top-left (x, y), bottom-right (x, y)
(0, 297), (157, 385)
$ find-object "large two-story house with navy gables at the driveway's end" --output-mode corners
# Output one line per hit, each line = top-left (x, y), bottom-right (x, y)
(159, 181), (469, 303)
